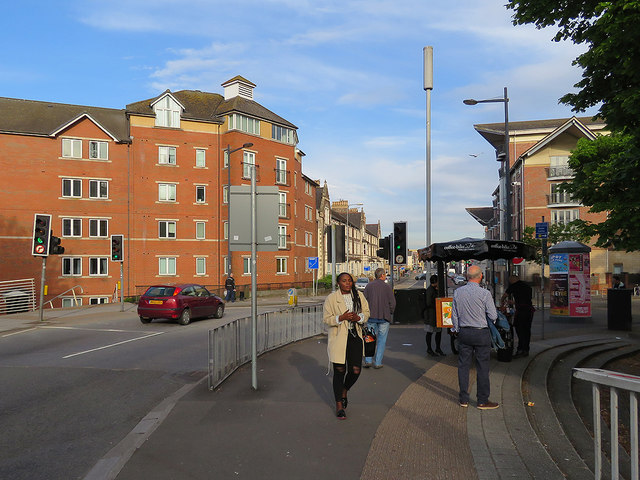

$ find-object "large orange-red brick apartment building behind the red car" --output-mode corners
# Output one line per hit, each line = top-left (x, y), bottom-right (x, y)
(0, 76), (317, 307)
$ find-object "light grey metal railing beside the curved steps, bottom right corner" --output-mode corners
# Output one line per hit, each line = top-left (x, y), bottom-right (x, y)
(573, 368), (640, 480)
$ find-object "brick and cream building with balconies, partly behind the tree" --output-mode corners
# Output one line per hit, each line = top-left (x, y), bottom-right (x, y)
(468, 117), (640, 289)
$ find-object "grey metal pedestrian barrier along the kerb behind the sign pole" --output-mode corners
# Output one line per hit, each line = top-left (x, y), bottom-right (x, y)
(209, 304), (324, 390)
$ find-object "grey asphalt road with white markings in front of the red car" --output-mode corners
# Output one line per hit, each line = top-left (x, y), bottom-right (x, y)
(0, 302), (302, 480)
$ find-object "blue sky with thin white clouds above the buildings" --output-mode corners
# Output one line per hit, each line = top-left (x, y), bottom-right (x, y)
(0, 0), (595, 248)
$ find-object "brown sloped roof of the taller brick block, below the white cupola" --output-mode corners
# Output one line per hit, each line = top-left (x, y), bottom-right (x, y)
(127, 90), (298, 129)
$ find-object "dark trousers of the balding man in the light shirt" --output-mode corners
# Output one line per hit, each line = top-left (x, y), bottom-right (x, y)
(458, 327), (491, 404)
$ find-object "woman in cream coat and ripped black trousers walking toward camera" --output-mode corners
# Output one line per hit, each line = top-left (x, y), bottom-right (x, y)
(323, 272), (369, 420)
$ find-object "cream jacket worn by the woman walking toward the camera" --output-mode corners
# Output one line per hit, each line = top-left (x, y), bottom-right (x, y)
(323, 289), (369, 363)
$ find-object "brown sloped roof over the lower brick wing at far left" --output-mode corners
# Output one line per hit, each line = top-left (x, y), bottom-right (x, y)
(0, 97), (130, 142)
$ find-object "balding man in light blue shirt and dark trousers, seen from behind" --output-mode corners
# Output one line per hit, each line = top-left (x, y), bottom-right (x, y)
(451, 265), (499, 410)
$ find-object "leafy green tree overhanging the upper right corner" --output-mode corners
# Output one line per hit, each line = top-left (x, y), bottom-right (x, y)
(507, 0), (640, 251)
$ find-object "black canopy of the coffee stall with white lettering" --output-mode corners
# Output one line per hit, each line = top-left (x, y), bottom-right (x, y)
(418, 237), (535, 262)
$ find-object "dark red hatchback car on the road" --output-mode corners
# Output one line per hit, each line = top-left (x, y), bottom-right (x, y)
(138, 283), (224, 325)
